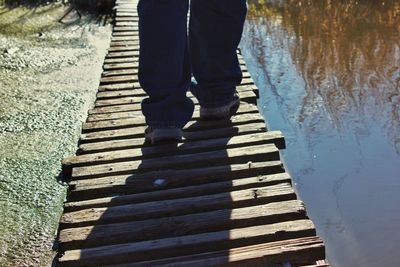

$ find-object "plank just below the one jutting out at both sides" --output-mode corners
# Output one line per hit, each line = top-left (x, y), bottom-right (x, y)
(72, 144), (279, 179)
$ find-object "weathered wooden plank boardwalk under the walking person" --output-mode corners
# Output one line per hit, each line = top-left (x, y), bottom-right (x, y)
(57, 0), (328, 266)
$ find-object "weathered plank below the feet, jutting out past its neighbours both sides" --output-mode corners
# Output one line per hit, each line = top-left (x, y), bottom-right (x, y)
(63, 132), (283, 168)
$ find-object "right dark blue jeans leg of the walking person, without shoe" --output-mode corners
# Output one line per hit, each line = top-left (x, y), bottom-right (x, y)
(189, 0), (247, 108)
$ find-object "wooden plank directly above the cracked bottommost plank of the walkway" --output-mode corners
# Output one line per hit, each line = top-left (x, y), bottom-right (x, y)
(59, 220), (315, 266)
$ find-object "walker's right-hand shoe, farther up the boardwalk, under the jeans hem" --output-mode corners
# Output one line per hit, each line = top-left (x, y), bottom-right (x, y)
(200, 94), (240, 120)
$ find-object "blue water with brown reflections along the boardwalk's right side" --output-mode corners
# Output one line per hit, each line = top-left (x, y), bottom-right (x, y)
(241, 0), (400, 267)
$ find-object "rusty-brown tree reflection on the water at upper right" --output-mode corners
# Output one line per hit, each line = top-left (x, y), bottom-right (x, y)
(249, 0), (400, 154)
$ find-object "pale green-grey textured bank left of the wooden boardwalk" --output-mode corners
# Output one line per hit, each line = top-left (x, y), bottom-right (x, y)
(0, 4), (111, 266)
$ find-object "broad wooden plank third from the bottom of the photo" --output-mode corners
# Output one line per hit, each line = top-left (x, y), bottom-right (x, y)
(59, 200), (306, 251)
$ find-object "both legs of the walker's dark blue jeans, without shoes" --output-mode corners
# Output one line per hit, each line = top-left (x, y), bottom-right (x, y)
(138, 0), (247, 128)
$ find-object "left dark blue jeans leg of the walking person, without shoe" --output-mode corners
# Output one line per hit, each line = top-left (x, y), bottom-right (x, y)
(138, 0), (194, 129)
